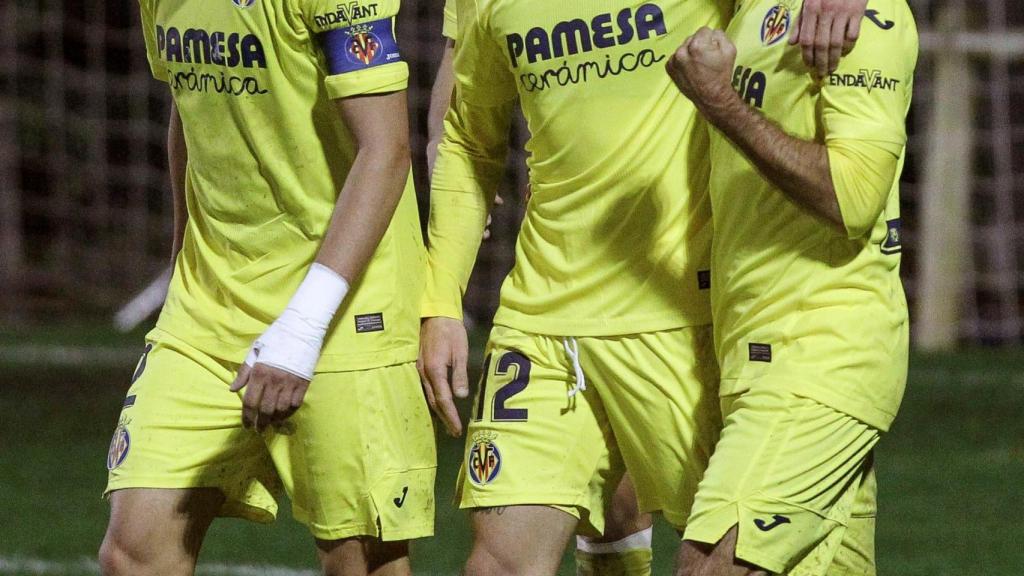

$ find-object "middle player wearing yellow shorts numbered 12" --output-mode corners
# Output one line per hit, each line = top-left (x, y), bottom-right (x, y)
(421, 0), (872, 574)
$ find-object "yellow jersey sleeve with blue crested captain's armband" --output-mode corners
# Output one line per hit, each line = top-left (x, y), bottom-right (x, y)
(298, 0), (409, 98)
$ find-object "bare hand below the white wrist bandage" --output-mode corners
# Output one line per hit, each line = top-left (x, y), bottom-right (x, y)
(231, 363), (309, 431)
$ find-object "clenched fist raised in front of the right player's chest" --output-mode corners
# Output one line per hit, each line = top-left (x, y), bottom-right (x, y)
(666, 27), (737, 114)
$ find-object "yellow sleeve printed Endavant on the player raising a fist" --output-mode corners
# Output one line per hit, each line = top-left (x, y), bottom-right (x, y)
(821, 0), (918, 149)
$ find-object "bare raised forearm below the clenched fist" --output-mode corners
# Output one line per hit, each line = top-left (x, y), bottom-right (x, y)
(699, 92), (845, 231)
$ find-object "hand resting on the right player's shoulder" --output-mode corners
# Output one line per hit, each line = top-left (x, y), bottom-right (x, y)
(790, 0), (867, 78)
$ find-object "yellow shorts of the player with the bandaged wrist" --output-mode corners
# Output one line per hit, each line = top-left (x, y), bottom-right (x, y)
(106, 334), (436, 540)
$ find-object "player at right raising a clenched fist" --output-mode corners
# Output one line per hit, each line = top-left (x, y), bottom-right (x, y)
(669, 0), (918, 576)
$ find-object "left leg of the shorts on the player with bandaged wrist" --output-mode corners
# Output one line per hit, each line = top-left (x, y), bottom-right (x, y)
(106, 339), (279, 522)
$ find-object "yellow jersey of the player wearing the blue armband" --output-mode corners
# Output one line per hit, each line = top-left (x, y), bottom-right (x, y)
(140, 0), (425, 371)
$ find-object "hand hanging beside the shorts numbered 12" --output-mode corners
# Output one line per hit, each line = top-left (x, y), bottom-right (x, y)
(416, 317), (469, 438)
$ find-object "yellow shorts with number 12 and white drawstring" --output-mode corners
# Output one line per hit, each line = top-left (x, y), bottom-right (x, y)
(458, 326), (721, 535)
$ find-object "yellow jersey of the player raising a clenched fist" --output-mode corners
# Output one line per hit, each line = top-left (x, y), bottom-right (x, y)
(711, 0), (918, 429)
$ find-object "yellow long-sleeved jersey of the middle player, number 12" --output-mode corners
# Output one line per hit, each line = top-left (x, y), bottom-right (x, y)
(423, 0), (732, 336)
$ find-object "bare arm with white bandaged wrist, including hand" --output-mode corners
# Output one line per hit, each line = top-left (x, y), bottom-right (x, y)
(231, 90), (410, 429)
